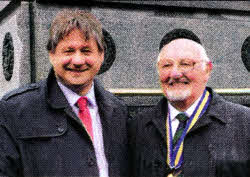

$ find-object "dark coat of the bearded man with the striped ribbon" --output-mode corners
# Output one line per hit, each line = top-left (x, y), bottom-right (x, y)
(129, 88), (250, 177)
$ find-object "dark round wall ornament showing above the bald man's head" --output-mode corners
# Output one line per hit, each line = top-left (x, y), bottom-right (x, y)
(159, 29), (201, 50)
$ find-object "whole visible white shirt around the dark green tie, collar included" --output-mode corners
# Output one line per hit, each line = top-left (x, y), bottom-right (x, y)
(168, 95), (202, 137)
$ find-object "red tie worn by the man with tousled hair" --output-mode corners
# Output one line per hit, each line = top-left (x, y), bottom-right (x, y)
(77, 96), (94, 141)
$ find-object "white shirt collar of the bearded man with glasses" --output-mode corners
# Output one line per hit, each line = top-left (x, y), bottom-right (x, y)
(168, 95), (205, 121)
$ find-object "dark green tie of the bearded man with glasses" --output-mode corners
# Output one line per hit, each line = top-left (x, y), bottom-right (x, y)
(173, 113), (188, 147)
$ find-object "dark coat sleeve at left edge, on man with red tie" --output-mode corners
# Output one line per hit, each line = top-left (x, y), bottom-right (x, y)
(0, 101), (22, 176)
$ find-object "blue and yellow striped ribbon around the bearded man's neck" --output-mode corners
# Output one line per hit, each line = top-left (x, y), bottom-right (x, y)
(166, 90), (211, 169)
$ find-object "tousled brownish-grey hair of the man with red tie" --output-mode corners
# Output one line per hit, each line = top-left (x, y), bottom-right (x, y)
(47, 10), (105, 53)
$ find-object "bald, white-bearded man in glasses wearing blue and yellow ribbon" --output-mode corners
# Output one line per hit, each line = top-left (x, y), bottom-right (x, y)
(129, 29), (250, 177)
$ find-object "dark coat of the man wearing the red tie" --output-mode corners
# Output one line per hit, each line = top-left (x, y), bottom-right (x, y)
(0, 72), (128, 176)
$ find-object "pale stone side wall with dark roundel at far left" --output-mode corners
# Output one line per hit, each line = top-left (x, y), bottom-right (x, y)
(0, 1), (31, 96)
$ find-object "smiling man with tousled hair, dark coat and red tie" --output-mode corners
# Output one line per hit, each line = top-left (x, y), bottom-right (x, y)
(0, 10), (128, 177)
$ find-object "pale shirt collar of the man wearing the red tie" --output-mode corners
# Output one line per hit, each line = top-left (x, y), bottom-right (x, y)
(57, 80), (96, 107)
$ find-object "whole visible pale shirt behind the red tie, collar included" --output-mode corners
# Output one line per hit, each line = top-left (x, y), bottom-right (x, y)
(57, 81), (108, 177)
